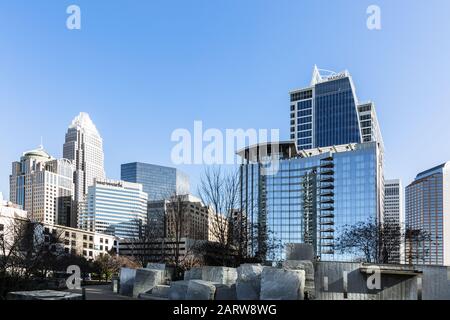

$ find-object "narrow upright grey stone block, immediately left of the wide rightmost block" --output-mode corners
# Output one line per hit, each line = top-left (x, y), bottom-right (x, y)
(236, 264), (264, 300)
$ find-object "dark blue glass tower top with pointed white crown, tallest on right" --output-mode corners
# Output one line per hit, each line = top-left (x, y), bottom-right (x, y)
(290, 66), (383, 150)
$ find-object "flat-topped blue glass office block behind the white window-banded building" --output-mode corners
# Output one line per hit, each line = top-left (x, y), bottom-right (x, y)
(121, 162), (189, 201)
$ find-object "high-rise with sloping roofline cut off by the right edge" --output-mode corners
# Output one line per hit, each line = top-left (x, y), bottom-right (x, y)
(405, 162), (450, 266)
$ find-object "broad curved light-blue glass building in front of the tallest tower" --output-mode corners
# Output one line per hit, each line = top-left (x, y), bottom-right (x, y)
(238, 142), (384, 261)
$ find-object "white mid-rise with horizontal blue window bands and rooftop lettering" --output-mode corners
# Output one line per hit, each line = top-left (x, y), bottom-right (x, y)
(79, 180), (147, 238)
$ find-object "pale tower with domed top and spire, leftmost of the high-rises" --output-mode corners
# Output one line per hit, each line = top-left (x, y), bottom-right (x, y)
(10, 146), (74, 225)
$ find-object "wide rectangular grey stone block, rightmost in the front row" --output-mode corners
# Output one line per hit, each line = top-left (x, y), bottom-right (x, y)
(260, 268), (305, 300)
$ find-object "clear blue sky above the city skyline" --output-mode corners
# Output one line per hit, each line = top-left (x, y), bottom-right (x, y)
(0, 0), (450, 196)
